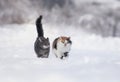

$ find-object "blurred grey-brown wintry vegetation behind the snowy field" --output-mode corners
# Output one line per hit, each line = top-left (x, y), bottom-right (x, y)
(0, 0), (120, 37)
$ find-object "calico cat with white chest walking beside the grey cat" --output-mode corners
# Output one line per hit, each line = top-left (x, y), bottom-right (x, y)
(52, 36), (72, 59)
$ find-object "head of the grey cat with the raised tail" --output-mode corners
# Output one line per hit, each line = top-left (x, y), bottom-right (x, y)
(38, 37), (50, 49)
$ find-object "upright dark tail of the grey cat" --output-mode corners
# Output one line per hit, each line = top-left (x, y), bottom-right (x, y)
(36, 15), (44, 37)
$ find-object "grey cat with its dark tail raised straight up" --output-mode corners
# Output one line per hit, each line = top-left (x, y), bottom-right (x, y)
(34, 15), (50, 58)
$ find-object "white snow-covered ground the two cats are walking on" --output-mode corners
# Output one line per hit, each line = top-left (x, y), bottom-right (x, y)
(0, 23), (120, 82)
